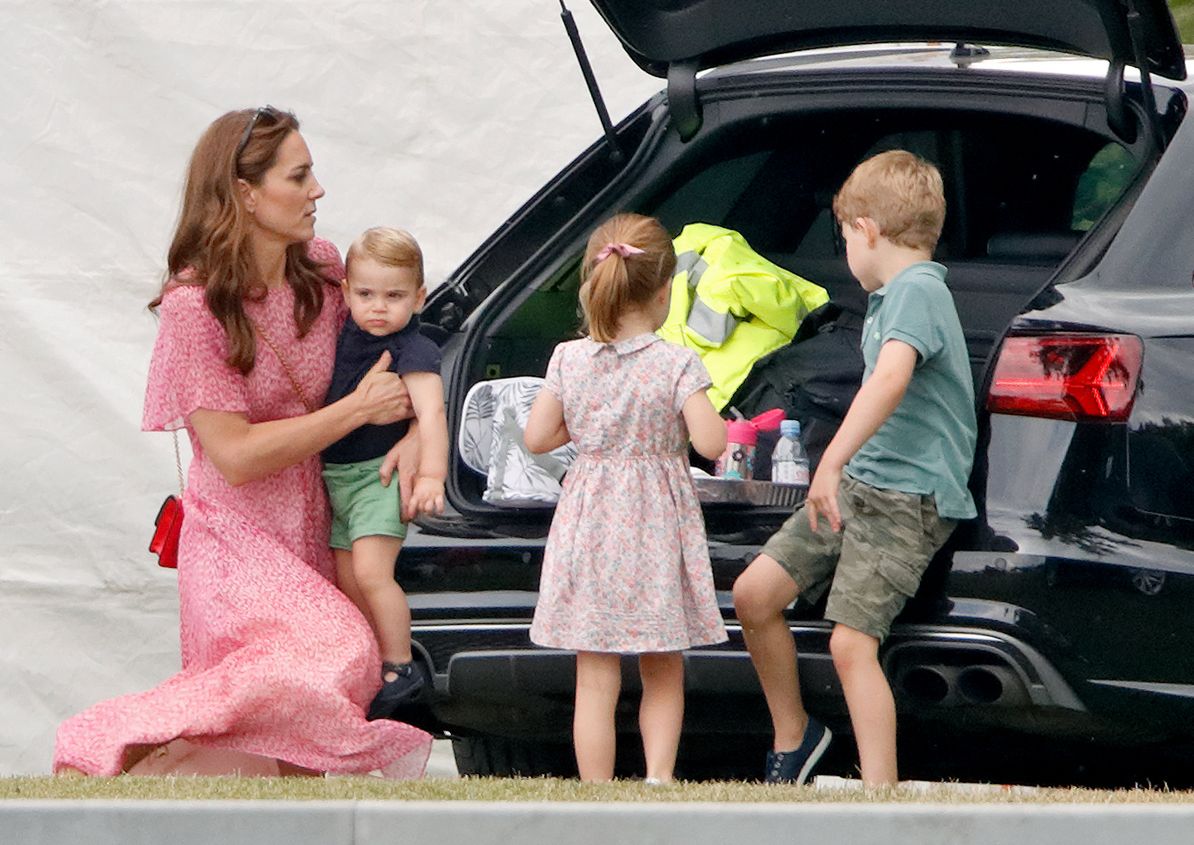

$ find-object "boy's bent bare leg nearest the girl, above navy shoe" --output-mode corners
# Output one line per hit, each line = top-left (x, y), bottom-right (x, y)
(734, 555), (808, 751)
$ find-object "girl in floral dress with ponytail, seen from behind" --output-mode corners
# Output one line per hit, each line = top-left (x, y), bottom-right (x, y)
(525, 214), (726, 783)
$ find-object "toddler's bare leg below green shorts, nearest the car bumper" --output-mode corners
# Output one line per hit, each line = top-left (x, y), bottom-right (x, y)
(352, 536), (411, 680)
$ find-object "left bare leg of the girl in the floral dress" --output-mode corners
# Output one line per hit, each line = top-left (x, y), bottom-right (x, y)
(572, 652), (622, 781)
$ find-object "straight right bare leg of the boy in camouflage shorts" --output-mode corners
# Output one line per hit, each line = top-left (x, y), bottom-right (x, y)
(829, 623), (899, 787)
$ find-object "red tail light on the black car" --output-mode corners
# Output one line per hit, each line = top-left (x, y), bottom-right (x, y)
(986, 334), (1144, 423)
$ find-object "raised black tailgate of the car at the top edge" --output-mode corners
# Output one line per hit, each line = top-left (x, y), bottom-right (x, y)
(592, 0), (1186, 140)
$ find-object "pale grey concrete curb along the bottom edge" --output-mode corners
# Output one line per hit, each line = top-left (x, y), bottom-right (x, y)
(7, 801), (1194, 845)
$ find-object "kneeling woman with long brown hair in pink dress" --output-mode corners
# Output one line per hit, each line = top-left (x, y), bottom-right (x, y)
(54, 106), (431, 777)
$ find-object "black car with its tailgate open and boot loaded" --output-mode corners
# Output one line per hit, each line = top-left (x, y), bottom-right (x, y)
(398, 0), (1194, 782)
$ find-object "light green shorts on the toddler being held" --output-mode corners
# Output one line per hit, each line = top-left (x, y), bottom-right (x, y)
(324, 457), (406, 550)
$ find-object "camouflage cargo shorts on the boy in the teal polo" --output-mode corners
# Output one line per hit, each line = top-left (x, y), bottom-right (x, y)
(761, 475), (956, 642)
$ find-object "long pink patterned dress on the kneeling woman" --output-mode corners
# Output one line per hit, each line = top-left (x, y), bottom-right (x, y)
(54, 241), (431, 777)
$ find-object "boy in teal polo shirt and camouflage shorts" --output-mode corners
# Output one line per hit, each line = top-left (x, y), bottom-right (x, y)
(734, 150), (975, 785)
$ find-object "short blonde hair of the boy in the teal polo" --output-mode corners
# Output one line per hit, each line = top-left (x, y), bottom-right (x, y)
(833, 149), (946, 253)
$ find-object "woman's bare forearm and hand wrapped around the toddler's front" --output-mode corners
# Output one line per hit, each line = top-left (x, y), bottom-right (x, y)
(189, 352), (411, 486)
